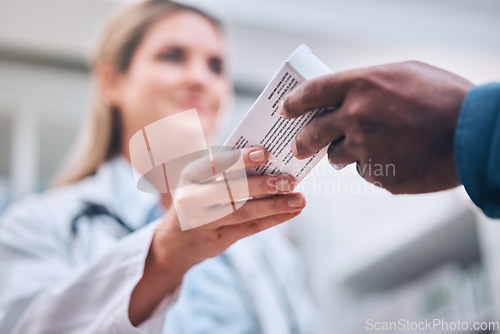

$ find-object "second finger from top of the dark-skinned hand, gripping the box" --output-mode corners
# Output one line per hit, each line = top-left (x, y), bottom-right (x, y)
(291, 110), (344, 159)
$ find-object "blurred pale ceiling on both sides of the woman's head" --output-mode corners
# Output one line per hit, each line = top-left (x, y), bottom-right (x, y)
(0, 0), (500, 89)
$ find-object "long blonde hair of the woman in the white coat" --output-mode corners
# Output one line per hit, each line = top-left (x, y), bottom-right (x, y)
(53, 0), (222, 187)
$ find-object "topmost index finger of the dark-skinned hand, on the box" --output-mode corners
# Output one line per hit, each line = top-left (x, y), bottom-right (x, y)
(278, 71), (349, 119)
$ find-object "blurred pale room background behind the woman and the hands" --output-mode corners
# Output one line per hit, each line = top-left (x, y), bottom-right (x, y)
(0, 0), (500, 333)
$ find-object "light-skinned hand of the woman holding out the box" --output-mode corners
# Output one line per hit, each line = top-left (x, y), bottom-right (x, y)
(129, 147), (305, 325)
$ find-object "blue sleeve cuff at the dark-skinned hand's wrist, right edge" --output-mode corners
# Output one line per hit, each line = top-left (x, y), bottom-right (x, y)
(455, 83), (500, 218)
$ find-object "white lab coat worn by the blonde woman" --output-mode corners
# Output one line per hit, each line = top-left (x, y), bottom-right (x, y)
(0, 158), (317, 334)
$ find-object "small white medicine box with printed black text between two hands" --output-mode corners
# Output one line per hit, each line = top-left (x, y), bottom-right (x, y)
(224, 46), (331, 182)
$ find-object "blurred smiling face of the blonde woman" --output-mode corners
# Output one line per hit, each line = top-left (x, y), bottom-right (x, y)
(112, 11), (232, 148)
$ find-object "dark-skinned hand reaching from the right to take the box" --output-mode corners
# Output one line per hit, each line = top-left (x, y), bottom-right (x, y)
(280, 61), (473, 194)
